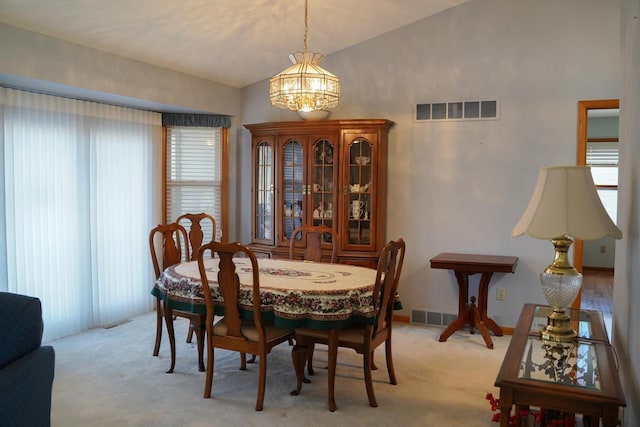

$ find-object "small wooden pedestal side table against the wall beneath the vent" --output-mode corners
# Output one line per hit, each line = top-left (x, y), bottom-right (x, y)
(431, 252), (518, 349)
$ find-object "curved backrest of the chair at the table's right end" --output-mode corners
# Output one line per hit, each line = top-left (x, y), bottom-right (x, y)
(373, 238), (405, 334)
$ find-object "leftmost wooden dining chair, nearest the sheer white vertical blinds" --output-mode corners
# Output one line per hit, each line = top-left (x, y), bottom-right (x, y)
(149, 223), (205, 373)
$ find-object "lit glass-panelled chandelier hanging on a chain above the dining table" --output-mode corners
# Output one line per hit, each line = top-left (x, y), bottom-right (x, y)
(269, 0), (340, 112)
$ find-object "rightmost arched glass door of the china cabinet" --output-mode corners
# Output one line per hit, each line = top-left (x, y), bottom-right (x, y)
(343, 138), (376, 247)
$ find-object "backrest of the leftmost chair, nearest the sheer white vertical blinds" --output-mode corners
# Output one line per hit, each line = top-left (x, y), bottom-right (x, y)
(149, 222), (190, 279)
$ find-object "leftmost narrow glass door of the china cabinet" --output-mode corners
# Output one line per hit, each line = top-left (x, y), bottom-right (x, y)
(253, 140), (275, 244)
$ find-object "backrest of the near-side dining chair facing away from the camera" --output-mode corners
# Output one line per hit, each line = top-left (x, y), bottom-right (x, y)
(198, 241), (265, 342)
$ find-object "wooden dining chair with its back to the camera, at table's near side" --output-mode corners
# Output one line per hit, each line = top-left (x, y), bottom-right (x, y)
(198, 242), (293, 411)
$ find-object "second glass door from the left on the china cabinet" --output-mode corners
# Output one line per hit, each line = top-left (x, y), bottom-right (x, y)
(280, 139), (305, 242)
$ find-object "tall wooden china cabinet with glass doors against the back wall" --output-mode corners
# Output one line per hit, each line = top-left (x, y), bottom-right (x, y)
(244, 119), (393, 268)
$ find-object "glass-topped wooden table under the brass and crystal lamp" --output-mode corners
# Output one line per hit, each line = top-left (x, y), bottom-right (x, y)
(495, 304), (625, 427)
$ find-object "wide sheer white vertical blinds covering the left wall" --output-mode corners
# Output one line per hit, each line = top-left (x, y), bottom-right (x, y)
(0, 88), (162, 340)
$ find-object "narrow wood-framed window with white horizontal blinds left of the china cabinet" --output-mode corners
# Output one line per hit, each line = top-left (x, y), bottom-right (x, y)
(166, 126), (222, 242)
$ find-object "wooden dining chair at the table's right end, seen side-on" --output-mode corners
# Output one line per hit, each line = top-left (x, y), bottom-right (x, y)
(293, 239), (405, 407)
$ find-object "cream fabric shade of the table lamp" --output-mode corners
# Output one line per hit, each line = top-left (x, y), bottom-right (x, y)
(511, 166), (622, 240)
